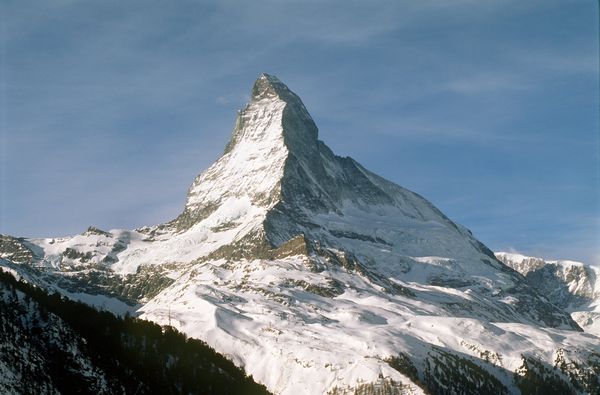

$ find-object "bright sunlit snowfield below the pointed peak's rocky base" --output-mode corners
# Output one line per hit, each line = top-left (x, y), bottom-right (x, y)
(141, 256), (600, 394)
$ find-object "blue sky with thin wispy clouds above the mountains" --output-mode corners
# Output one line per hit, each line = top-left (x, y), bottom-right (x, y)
(0, 0), (600, 263)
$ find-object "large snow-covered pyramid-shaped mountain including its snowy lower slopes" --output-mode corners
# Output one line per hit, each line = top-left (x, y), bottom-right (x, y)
(0, 74), (600, 395)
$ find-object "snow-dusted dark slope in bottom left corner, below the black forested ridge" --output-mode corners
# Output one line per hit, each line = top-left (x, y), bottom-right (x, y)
(0, 268), (113, 394)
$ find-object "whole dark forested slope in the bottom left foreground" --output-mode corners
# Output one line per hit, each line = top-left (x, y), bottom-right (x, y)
(0, 270), (267, 395)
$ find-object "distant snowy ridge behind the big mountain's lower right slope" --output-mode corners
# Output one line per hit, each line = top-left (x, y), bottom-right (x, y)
(496, 252), (600, 336)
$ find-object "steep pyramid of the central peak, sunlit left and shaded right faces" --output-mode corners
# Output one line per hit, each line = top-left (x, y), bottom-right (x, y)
(169, 74), (499, 268)
